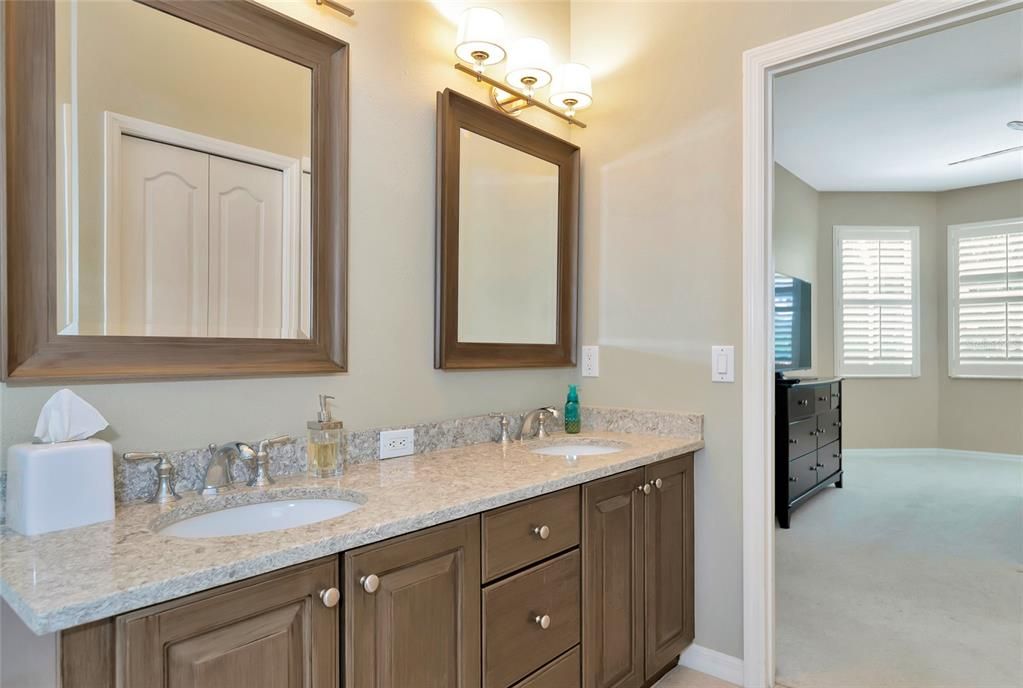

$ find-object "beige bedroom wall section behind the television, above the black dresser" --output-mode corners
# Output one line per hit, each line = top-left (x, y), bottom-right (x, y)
(772, 163), (821, 373)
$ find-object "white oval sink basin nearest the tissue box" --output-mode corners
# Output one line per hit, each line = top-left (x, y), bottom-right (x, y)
(158, 499), (362, 538)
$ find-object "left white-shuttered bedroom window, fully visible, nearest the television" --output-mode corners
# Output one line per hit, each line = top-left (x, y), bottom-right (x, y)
(835, 226), (920, 377)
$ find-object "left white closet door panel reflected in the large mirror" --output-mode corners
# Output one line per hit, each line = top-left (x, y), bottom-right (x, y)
(116, 136), (210, 336)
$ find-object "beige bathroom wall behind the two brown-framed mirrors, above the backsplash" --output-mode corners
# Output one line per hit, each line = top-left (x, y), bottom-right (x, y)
(0, 0), (577, 462)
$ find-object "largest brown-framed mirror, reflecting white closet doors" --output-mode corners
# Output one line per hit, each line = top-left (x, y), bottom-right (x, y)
(0, 0), (348, 381)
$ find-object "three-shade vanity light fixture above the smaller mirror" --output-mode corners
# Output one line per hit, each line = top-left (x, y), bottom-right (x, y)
(454, 7), (593, 128)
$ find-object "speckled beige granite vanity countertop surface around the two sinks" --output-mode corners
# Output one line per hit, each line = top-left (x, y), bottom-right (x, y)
(0, 432), (704, 635)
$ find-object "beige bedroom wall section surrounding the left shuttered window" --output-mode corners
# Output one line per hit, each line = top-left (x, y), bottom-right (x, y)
(816, 192), (944, 448)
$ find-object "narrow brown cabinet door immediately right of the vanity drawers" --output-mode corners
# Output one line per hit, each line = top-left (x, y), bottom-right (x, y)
(582, 468), (646, 688)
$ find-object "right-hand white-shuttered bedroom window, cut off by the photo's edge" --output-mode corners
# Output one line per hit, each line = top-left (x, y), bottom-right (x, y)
(948, 218), (1023, 377)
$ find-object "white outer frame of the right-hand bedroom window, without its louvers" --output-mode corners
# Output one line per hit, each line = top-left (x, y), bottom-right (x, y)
(945, 217), (1023, 380)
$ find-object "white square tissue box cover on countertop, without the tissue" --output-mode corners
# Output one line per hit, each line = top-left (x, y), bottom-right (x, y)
(7, 440), (114, 535)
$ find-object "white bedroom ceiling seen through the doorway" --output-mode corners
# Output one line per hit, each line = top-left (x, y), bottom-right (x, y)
(774, 9), (1023, 191)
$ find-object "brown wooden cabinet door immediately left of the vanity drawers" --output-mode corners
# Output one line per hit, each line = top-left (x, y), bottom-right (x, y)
(345, 516), (481, 688)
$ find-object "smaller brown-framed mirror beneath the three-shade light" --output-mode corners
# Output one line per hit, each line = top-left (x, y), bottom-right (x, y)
(435, 90), (579, 369)
